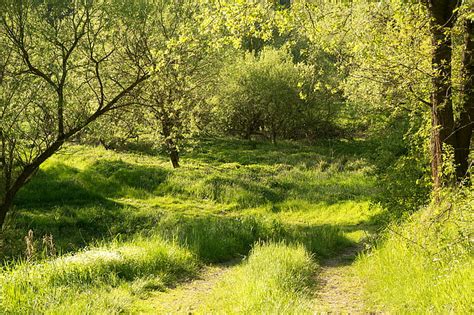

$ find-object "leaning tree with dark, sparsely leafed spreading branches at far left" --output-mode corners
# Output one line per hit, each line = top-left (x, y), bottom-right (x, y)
(0, 0), (148, 225)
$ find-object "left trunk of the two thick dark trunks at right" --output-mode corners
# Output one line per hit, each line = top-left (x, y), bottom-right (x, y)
(427, 0), (458, 190)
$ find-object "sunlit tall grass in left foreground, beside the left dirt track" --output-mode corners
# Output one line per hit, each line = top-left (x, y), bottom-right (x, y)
(0, 237), (198, 314)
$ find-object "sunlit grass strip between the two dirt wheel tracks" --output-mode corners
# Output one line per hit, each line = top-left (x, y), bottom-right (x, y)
(198, 243), (317, 314)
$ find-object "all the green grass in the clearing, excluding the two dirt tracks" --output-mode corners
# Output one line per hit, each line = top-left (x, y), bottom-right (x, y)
(0, 139), (473, 314)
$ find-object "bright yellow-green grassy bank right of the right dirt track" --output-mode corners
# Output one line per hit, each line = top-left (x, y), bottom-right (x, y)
(356, 189), (474, 314)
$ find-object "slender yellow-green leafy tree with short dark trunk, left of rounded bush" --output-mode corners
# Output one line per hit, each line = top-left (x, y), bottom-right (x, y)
(125, 0), (218, 168)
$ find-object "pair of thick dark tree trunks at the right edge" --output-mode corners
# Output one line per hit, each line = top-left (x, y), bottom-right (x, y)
(425, 0), (474, 188)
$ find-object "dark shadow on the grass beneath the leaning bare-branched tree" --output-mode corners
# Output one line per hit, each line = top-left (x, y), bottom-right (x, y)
(0, 161), (167, 259)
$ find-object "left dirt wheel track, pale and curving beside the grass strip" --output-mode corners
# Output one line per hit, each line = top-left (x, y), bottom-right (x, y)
(139, 259), (241, 314)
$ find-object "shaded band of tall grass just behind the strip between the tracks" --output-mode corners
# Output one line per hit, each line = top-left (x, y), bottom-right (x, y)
(153, 214), (353, 263)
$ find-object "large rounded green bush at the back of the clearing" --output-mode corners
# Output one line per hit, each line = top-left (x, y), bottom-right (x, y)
(216, 48), (338, 141)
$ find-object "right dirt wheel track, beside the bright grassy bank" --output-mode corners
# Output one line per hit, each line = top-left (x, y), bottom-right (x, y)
(314, 247), (367, 314)
